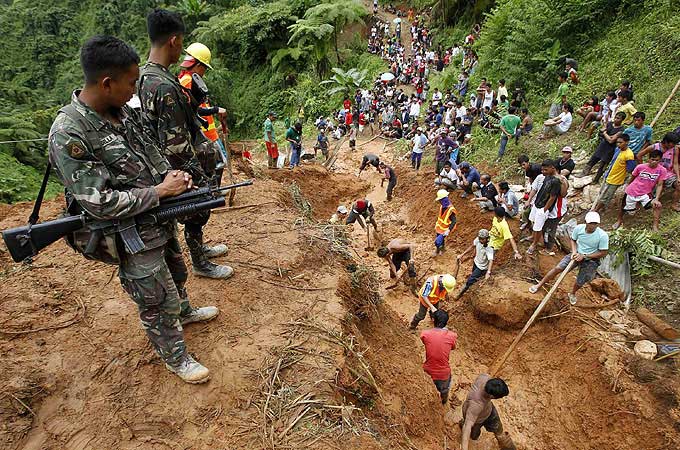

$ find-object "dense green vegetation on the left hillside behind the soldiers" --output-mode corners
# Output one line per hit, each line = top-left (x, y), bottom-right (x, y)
(0, 0), (372, 202)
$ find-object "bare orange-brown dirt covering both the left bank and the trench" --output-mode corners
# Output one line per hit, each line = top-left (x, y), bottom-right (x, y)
(0, 137), (680, 450)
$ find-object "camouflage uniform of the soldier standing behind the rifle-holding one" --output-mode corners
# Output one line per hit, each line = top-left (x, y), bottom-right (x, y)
(137, 62), (220, 265)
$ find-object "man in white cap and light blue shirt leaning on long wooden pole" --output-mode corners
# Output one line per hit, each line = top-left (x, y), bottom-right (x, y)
(529, 211), (609, 305)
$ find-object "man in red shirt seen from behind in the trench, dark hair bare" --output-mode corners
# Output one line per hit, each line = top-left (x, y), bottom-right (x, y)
(420, 309), (458, 405)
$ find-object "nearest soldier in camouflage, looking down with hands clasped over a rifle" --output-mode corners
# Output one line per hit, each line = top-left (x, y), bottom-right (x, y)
(49, 36), (219, 383)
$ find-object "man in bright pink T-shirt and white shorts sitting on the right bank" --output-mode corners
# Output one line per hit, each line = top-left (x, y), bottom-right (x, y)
(613, 150), (668, 231)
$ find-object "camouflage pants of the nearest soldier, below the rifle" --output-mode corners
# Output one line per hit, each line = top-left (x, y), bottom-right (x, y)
(119, 237), (191, 365)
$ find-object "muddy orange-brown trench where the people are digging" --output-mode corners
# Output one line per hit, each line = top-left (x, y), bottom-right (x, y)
(274, 144), (680, 450)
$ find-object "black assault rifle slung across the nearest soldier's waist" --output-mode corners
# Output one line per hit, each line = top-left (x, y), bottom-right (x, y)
(2, 180), (253, 262)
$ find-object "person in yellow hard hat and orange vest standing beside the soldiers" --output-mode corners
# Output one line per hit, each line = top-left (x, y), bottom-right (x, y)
(178, 42), (229, 182)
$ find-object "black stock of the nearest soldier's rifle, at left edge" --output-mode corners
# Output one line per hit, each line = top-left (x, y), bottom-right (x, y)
(2, 214), (86, 262)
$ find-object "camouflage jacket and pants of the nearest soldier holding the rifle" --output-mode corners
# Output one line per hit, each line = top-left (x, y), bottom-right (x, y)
(49, 91), (192, 365)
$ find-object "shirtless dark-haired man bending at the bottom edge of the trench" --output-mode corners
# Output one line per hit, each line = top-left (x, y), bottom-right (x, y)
(460, 373), (516, 450)
